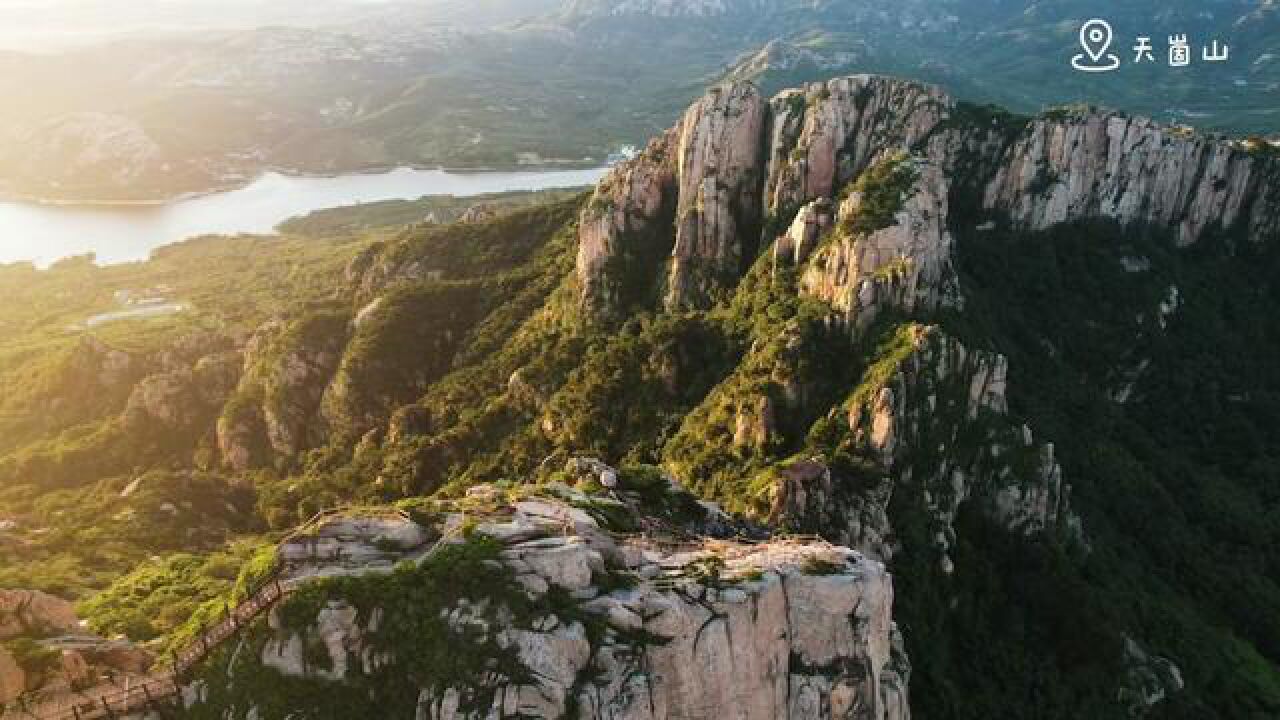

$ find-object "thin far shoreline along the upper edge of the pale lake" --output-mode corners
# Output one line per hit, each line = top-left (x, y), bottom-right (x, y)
(0, 163), (607, 210)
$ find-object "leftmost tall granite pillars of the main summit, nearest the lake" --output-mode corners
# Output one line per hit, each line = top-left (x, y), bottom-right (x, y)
(577, 83), (767, 314)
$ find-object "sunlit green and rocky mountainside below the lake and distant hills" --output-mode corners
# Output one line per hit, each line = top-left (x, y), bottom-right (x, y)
(0, 70), (1280, 720)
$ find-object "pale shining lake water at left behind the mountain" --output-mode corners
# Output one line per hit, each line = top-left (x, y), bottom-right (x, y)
(0, 168), (605, 266)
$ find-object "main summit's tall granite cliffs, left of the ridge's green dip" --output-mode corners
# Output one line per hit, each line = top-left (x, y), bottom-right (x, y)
(577, 76), (948, 316)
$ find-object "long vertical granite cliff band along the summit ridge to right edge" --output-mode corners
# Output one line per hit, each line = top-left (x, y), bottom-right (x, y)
(577, 76), (1280, 322)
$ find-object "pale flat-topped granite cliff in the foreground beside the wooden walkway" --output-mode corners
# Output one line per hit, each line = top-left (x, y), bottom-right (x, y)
(188, 471), (910, 720)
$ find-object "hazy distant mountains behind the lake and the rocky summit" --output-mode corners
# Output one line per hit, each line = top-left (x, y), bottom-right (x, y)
(0, 0), (1280, 200)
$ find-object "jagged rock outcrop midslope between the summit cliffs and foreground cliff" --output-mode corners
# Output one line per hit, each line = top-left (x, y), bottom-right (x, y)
(776, 325), (1080, 569)
